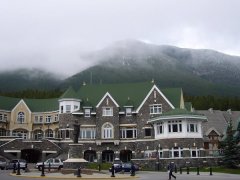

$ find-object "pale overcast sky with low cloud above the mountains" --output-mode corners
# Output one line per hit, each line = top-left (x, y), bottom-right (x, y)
(0, 0), (240, 75)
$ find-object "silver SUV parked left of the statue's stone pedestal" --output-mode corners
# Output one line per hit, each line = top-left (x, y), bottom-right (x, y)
(35, 158), (63, 171)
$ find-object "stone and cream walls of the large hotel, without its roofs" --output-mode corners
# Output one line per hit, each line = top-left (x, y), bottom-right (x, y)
(0, 82), (238, 168)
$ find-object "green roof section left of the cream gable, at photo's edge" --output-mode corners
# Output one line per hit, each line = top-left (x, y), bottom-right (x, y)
(0, 96), (21, 111)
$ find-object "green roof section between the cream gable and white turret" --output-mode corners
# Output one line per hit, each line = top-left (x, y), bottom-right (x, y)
(23, 98), (59, 112)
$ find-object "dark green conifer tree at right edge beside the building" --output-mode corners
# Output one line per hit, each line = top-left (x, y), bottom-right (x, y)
(222, 119), (240, 168)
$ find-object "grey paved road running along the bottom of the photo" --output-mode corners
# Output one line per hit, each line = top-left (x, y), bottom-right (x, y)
(0, 170), (240, 180)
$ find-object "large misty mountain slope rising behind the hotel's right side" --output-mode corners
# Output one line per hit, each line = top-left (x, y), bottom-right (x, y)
(63, 41), (240, 96)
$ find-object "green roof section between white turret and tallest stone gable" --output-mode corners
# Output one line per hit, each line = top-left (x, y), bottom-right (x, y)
(78, 82), (153, 107)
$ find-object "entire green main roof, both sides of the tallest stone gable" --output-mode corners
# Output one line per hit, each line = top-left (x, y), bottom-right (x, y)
(77, 82), (182, 108)
